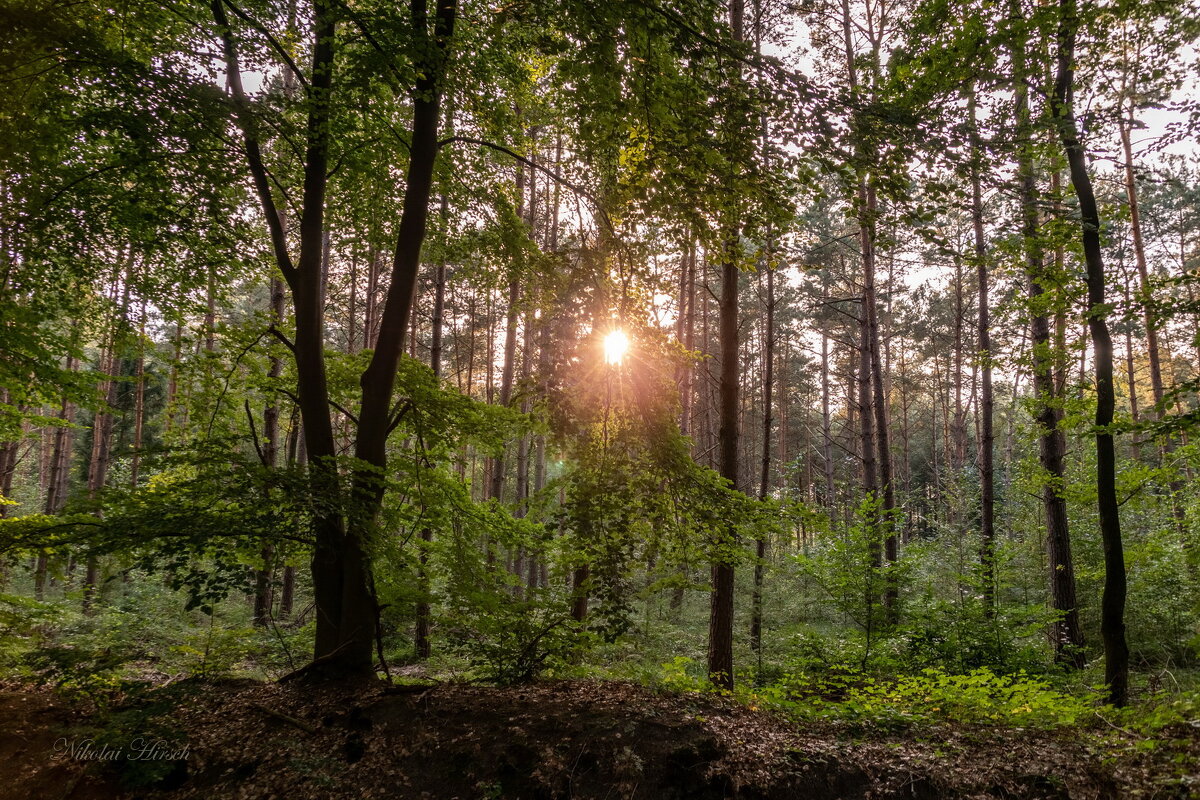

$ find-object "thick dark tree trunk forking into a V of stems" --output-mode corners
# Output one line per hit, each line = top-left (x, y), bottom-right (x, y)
(211, 0), (457, 673)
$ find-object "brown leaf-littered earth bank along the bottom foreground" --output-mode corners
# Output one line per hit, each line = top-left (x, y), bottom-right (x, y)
(0, 681), (1200, 800)
